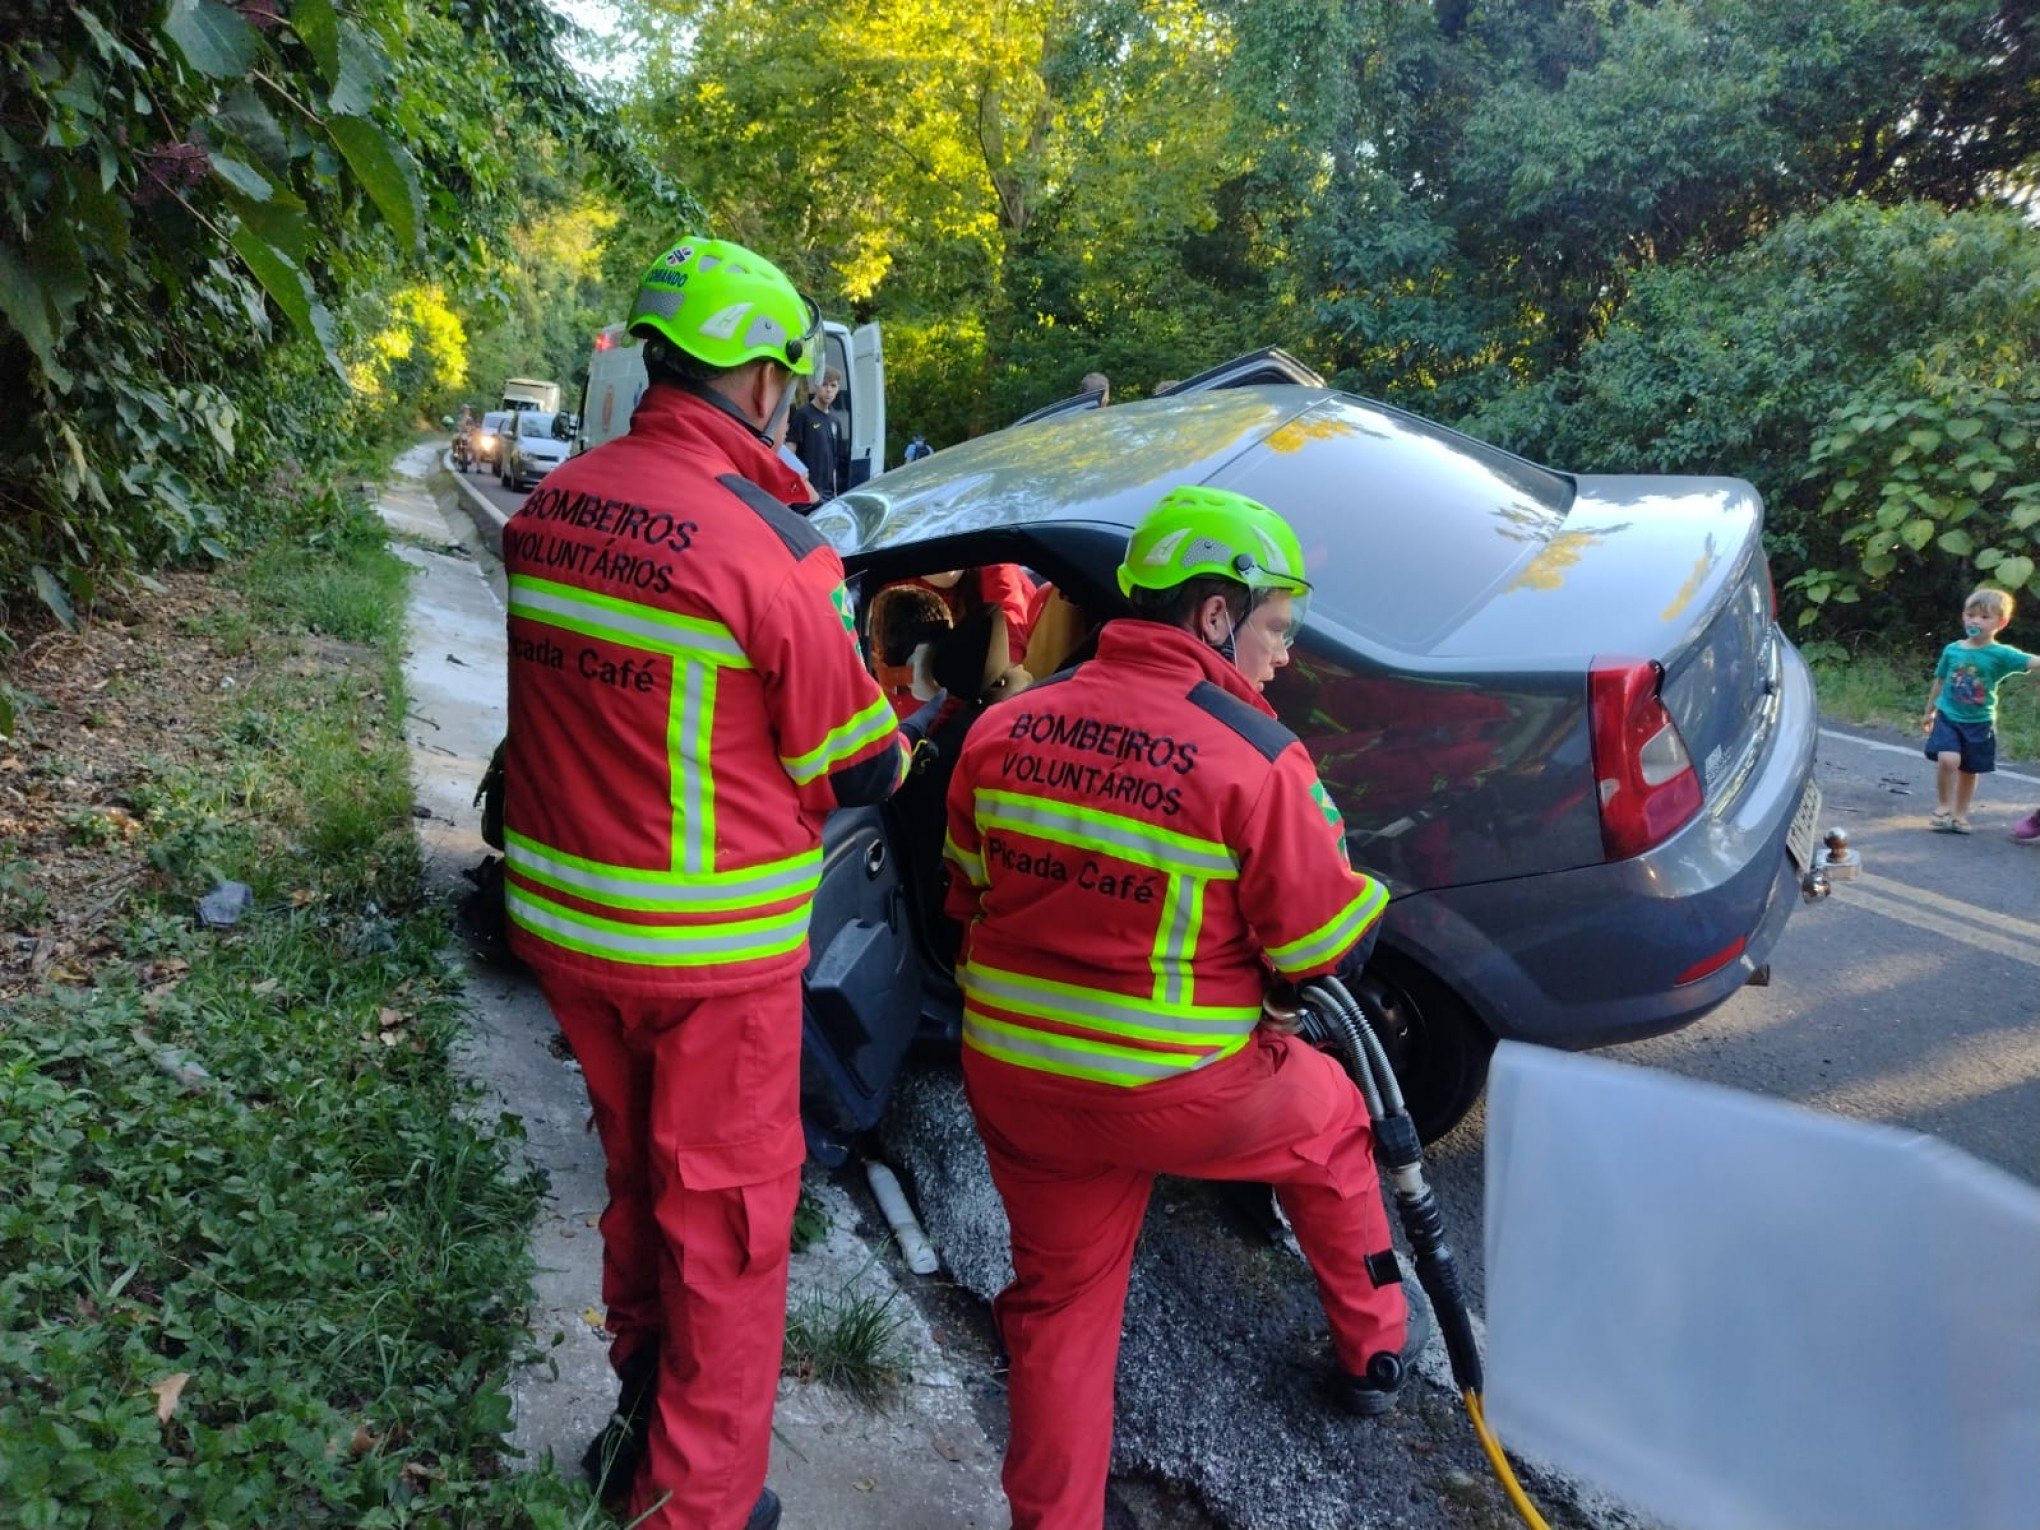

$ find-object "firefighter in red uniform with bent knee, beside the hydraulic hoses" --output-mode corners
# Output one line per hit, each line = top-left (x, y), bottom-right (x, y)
(947, 488), (1422, 1530)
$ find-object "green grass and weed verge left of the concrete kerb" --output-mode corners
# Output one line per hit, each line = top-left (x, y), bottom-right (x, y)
(0, 497), (600, 1530)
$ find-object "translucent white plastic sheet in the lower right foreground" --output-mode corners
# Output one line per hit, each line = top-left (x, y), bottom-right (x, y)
(1487, 1044), (2040, 1530)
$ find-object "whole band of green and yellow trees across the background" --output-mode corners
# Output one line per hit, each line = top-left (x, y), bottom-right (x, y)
(0, 0), (2040, 644)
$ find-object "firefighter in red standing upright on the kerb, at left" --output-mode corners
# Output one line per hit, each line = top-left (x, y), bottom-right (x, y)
(504, 239), (908, 1530)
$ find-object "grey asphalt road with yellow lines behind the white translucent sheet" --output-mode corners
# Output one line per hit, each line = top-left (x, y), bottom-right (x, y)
(1430, 728), (2040, 1330)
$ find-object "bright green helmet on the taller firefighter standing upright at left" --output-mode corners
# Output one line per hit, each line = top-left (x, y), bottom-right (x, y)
(626, 239), (822, 377)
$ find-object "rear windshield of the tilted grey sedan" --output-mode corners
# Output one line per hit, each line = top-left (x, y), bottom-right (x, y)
(1212, 398), (1573, 653)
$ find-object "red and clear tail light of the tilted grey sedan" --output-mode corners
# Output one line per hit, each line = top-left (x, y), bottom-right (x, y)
(1587, 659), (1703, 861)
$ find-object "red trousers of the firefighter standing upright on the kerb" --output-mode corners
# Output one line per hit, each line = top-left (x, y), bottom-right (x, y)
(539, 973), (802, 1530)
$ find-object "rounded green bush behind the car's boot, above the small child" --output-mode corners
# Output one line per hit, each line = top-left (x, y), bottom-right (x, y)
(1469, 202), (2040, 641)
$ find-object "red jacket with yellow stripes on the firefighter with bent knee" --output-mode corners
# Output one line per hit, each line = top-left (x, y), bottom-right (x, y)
(945, 620), (1387, 1085)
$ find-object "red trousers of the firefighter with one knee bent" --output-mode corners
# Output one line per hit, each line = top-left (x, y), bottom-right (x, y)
(963, 1032), (1408, 1530)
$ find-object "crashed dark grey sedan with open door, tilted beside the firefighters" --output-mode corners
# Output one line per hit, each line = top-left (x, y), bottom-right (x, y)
(787, 353), (1820, 1159)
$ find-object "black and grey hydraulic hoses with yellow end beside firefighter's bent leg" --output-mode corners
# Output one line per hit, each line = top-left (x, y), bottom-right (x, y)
(1299, 977), (1548, 1530)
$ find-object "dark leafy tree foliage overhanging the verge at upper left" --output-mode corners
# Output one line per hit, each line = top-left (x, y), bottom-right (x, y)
(0, 0), (663, 620)
